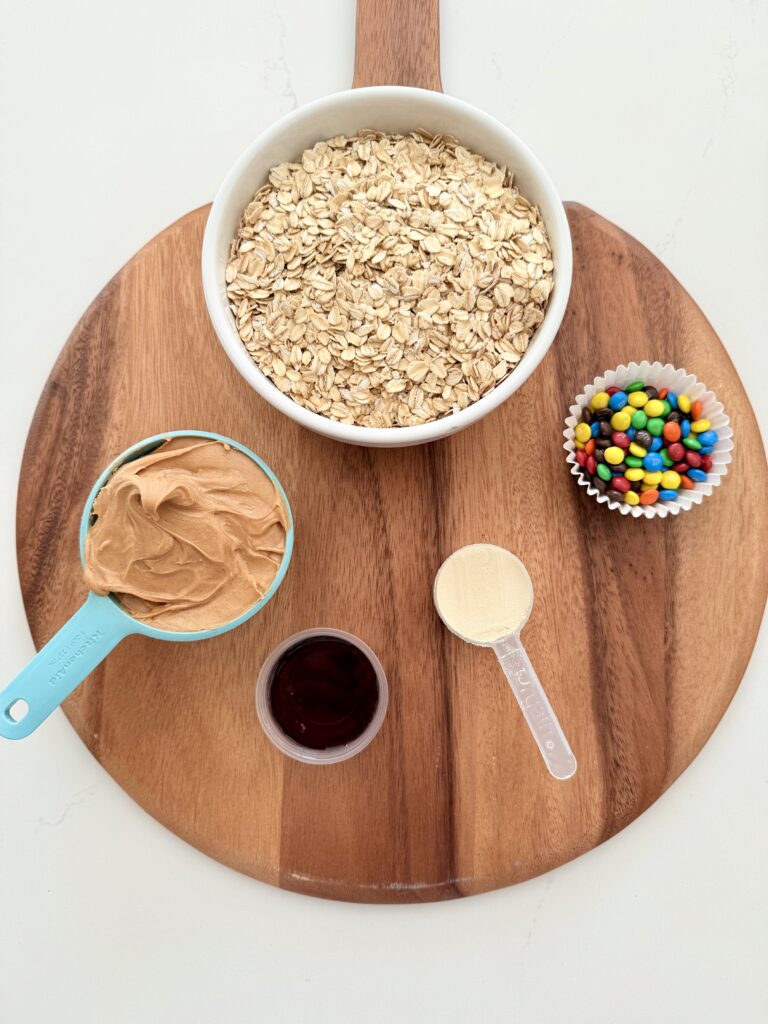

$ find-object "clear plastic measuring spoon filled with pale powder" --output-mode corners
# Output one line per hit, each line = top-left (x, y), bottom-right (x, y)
(433, 544), (577, 779)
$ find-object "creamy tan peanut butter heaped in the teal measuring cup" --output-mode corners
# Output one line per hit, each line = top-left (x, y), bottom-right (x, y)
(85, 437), (289, 631)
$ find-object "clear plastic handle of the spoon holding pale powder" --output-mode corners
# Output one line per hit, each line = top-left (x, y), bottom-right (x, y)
(493, 635), (577, 779)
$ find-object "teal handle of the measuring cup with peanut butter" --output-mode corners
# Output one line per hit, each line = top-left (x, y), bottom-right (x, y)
(0, 594), (133, 739)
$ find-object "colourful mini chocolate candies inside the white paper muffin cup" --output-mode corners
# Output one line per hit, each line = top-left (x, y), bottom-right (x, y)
(573, 380), (718, 506)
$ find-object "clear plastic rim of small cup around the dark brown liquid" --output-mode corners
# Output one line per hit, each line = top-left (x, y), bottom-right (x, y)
(256, 628), (389, 765)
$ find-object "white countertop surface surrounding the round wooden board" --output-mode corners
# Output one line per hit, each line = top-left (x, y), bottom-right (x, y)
(0, 0), (768, 1024)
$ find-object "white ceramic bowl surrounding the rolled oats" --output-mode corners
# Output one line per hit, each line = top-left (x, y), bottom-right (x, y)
(203, 86), (572, 447)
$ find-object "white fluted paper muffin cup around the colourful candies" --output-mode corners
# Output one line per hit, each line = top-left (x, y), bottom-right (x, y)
(563, 361), (733, 519)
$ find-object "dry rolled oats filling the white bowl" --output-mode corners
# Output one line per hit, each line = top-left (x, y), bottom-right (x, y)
(226, 131), (553, 427)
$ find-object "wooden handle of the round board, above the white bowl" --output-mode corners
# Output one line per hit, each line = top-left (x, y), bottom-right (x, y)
(352, 0), (442, 92)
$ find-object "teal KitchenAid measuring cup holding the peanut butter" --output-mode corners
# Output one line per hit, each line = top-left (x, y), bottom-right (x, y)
(0, 430), (294, 739)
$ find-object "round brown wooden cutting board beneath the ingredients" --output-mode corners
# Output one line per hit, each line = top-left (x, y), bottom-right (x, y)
(17, 4), (768, 902)
